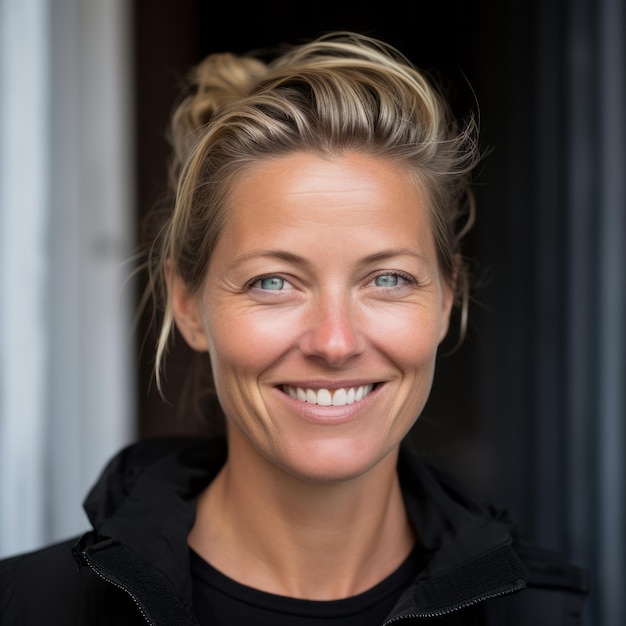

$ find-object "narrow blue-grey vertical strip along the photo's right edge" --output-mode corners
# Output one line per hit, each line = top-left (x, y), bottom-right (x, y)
(593, 0), (626, 625)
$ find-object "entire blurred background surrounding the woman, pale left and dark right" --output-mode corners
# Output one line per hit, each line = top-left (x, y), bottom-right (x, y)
(0, 0), (626, 626)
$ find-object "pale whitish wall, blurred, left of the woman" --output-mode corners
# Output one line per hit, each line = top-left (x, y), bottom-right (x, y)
(0, 0), (135, 556)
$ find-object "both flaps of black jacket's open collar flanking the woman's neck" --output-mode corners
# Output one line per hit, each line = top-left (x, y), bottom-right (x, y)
(75, 438), (528, 624)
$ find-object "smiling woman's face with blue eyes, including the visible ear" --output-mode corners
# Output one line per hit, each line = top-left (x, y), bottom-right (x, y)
(174, 153), (452, 481)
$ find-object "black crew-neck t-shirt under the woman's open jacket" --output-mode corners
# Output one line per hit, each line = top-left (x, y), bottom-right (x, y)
(191, 548), (423, 626)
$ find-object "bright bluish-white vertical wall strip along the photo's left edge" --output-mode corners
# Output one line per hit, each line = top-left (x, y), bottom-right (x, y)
(0, 0), (50, 554)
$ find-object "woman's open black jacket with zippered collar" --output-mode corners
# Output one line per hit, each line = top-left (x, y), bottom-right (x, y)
(0, 438), (587, 626)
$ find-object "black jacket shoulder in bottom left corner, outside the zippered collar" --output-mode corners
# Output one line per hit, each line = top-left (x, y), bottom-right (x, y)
(0, 538), (141, 626)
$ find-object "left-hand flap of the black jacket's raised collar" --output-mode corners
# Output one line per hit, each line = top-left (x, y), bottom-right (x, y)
(80, 438), (226, 625)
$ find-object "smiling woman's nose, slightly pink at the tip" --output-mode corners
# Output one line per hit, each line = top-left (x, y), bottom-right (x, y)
(300, 294), (365, 368)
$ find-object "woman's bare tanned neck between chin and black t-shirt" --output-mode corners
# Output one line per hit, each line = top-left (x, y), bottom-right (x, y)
(189, 436), (415, 600)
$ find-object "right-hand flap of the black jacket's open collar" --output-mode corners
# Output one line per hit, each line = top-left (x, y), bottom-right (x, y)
(390, 446), (529, 619)
